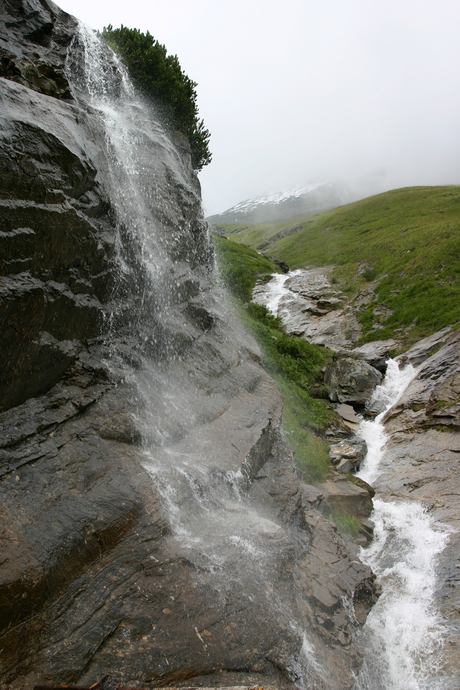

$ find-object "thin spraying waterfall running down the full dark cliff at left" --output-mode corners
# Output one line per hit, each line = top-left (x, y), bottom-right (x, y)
(63, 25), (323, 689)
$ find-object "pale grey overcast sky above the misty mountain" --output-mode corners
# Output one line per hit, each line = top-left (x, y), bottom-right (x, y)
(54, 0), (460, 215)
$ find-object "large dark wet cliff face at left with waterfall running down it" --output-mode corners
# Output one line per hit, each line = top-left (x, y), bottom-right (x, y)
(0, 0), (376, 688)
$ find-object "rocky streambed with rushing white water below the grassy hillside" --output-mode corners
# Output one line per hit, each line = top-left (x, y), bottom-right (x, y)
(254, 268), (460, 690)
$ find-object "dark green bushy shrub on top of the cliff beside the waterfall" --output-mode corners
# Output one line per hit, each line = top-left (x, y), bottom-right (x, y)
(102, 24), (211, 170)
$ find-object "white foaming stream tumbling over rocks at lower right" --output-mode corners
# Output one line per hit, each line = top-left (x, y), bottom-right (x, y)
(355, 360), (449, 690)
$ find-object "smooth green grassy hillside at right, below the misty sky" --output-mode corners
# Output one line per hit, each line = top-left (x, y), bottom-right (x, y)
(216, 186), (460, 342)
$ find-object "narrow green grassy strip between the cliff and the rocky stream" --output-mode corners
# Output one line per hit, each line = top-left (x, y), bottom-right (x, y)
(214, 237), (334, 481)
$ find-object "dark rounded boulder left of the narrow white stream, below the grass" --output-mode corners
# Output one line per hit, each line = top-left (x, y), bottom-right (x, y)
(324, 357), (382, 405)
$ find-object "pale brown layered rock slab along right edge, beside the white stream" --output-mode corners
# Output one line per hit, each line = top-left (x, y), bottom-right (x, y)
(376, 331), (460, 683)
